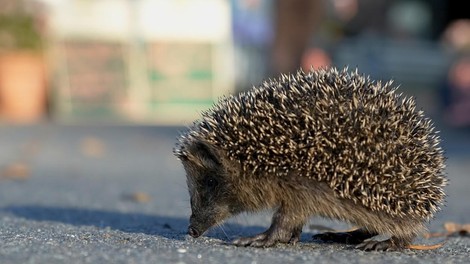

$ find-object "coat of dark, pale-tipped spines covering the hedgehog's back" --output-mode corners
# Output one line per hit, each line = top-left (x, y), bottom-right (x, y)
(180, 68), (446, 219)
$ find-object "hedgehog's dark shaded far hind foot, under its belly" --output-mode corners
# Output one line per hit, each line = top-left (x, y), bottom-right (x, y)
(313, 228), (377, 245)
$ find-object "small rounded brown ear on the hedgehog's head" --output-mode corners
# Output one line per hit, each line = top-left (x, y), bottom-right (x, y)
(187, 141), (220, 169)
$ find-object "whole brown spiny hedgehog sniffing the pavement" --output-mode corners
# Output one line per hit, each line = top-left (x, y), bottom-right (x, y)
(174, 67), (447, 251)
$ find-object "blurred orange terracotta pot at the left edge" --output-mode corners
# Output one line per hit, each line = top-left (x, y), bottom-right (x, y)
(0, 52), (46, 123)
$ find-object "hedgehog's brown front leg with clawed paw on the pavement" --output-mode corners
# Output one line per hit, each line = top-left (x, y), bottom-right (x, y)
(233, 208), (305, 247)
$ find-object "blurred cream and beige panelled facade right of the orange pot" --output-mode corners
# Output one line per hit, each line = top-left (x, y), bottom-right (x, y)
(46, 0), (233, 124)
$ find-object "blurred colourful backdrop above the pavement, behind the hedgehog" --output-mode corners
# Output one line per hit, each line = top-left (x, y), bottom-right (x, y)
(0, 0), (470, 128)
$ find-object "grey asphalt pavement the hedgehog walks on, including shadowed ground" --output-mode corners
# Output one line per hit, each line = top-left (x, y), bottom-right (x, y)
(0, 124), (470, 263)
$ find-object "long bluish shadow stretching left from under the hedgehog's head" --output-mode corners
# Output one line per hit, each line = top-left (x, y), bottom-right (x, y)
(0, 205), (286, 242)
